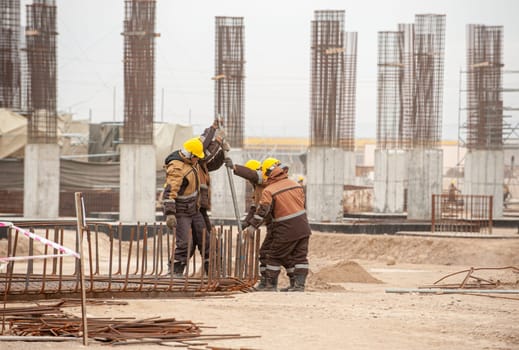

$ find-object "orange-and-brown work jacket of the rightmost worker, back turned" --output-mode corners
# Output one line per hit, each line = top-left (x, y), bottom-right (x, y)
(251, 167), (312, 242)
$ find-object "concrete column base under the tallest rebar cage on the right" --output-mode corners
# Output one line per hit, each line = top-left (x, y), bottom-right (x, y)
(407, 149), (443, 220)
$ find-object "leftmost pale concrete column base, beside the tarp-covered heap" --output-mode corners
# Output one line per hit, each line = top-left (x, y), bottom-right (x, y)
(23, 144), (60, 219)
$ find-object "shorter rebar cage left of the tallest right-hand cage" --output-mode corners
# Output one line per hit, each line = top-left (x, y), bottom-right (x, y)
(377, 31), (405, 149)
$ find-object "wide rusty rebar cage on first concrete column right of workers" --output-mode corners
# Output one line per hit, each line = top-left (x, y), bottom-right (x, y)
(310, 10), (357, 151)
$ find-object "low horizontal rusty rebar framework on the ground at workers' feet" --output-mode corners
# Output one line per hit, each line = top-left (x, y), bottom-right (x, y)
(0, 223), (259, 299)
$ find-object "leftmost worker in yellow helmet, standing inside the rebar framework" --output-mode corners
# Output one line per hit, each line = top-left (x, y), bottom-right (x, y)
(163, 137), (209, 278)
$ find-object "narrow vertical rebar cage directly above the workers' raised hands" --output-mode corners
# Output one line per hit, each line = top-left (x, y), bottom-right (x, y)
(213, 17), (245, 148)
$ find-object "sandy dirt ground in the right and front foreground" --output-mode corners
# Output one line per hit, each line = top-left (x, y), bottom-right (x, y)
(0, 232), (519, 350)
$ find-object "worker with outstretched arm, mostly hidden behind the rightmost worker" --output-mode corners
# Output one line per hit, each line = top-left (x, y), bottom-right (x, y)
(225, 158), (279, 290)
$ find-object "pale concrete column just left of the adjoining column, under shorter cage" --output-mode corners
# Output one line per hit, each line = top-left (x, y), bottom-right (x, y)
(373, 149), (407, 213)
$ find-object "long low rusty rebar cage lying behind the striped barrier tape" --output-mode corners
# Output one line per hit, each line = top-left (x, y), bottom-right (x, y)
(0, 222), (260, 300)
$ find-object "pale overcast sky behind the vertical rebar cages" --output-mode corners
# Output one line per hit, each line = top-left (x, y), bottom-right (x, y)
(22, 0), (519, 140)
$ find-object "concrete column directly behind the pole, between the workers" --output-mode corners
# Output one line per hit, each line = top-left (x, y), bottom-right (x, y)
(209, 148), (248, 219)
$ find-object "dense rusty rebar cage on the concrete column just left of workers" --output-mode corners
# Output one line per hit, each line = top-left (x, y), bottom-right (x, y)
(122, 0), (157, 144)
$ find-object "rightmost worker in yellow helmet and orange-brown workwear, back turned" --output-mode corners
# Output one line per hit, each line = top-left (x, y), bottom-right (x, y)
(249, 159), (311, 292)
